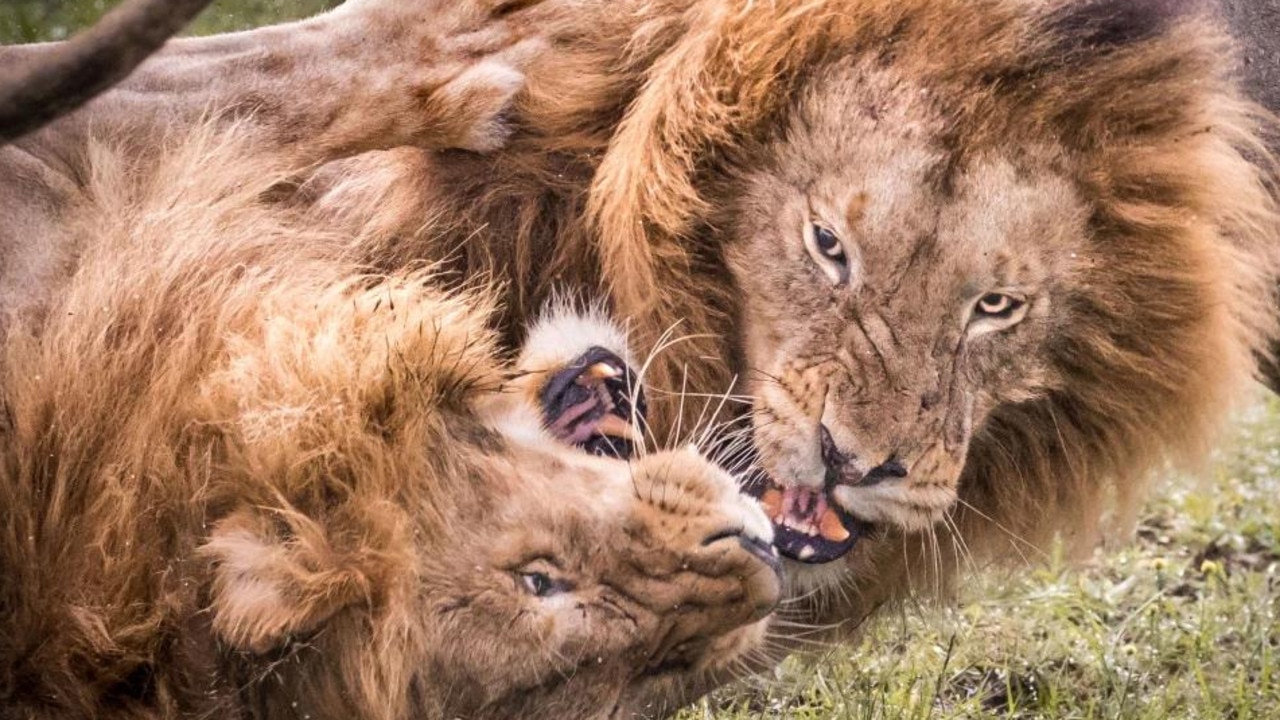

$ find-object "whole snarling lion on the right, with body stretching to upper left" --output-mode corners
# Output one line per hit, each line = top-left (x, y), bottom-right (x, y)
(2, 0), (1280, 712)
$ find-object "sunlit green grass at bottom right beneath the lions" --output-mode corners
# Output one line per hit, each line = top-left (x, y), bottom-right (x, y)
(680, 397), (1280, 720)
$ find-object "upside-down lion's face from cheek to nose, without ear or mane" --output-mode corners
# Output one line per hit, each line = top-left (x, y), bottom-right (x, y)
(425, 441), (781, 717)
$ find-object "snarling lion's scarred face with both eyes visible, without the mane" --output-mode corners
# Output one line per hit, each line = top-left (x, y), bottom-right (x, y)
(726, 61), (1087, 562)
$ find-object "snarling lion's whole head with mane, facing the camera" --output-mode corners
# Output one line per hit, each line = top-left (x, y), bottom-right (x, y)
(576, 0), (1280, 586)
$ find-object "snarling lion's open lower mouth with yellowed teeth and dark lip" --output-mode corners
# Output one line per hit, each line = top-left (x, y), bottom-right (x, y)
(746, 477), (870, 565)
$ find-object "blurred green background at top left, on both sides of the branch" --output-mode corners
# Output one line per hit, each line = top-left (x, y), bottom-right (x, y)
(0, 0), (342, 44)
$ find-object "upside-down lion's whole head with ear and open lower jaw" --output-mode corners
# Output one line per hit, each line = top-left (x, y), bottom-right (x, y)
(200, 288), (782, 720)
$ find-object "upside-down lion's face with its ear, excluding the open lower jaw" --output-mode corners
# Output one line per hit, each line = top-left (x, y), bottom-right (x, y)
(201, 353), (782, 720)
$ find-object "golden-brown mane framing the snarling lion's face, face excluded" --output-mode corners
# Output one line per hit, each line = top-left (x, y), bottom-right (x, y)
(307, 0), (1280, 612)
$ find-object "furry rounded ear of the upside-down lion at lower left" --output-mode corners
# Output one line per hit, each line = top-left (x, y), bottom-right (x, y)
(200, 509), (401, 653)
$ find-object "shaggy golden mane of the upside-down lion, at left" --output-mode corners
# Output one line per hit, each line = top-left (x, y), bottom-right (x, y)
(0, 122), (504, 717)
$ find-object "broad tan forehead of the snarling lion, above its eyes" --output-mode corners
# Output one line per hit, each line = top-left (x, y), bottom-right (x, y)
(788, 68), (1085, 297)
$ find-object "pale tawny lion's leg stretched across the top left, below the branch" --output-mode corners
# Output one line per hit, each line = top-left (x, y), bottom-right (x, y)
(0, 0), (543, 336)
